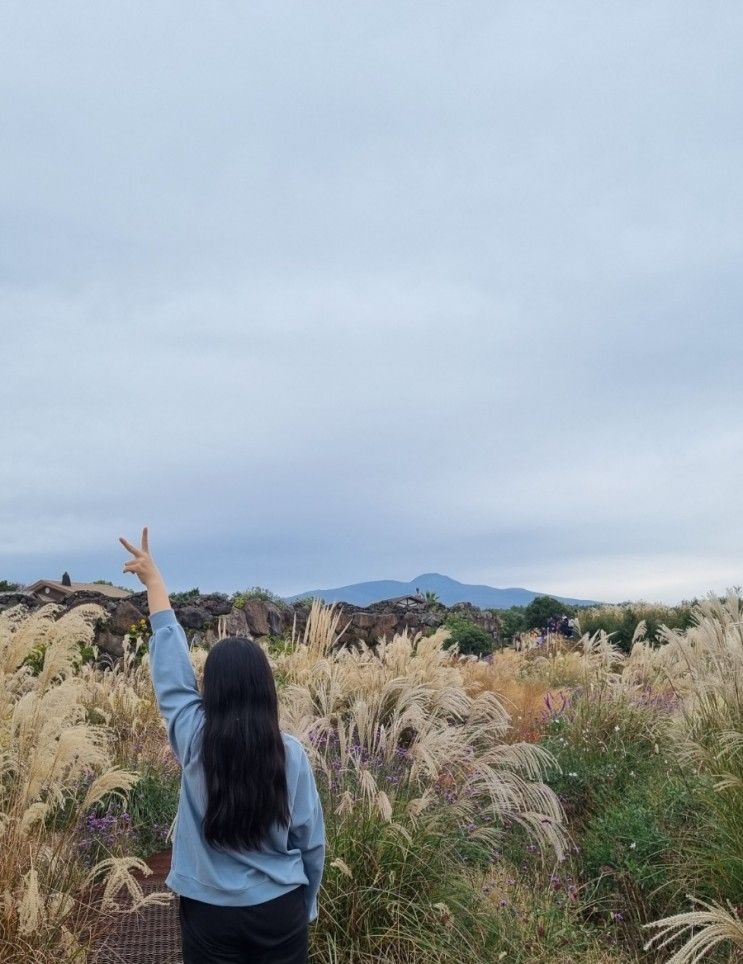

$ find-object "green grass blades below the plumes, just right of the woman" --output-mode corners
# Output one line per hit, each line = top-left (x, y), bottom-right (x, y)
(310, 744), (506, 964)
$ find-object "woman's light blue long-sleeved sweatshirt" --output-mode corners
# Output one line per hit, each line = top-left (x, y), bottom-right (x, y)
(150, 609), (325, 923)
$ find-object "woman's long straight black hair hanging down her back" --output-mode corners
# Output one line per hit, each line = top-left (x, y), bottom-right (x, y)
(201, 636), (289, 850)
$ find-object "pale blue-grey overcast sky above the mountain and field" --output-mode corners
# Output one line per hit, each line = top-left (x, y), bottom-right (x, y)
(0, 0), (743, 601)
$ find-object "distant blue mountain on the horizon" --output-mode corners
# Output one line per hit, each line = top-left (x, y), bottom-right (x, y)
(285, 572), (595, 609)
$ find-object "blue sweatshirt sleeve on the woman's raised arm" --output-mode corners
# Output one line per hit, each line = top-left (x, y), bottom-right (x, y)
(149, 609), (203, 765)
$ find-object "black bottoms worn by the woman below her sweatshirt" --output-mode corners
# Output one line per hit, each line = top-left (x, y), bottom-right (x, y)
(178, 884), (308, 964)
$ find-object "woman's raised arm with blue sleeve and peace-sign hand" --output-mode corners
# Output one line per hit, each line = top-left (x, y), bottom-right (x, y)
(120, 527), (202, 765)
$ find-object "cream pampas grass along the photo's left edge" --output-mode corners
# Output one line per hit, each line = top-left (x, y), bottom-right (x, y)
(0, 605), (169, 964)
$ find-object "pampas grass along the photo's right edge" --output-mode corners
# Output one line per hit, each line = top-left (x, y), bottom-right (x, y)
(628, 590), (743, 964)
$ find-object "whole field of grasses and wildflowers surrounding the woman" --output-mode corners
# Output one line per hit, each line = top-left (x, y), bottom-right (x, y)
(0, 591), (743, 964)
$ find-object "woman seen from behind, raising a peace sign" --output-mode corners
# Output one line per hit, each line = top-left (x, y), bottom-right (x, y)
(120, 527), (325, 964)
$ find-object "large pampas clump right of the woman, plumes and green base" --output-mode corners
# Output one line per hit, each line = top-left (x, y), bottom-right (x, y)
(276, 604), (564, 964)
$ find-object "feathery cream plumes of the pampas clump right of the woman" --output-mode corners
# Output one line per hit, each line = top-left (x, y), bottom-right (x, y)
(277, 607), (564, 857)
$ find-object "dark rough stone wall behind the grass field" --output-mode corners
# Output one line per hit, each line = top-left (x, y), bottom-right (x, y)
(0, 591), (499, 656)
